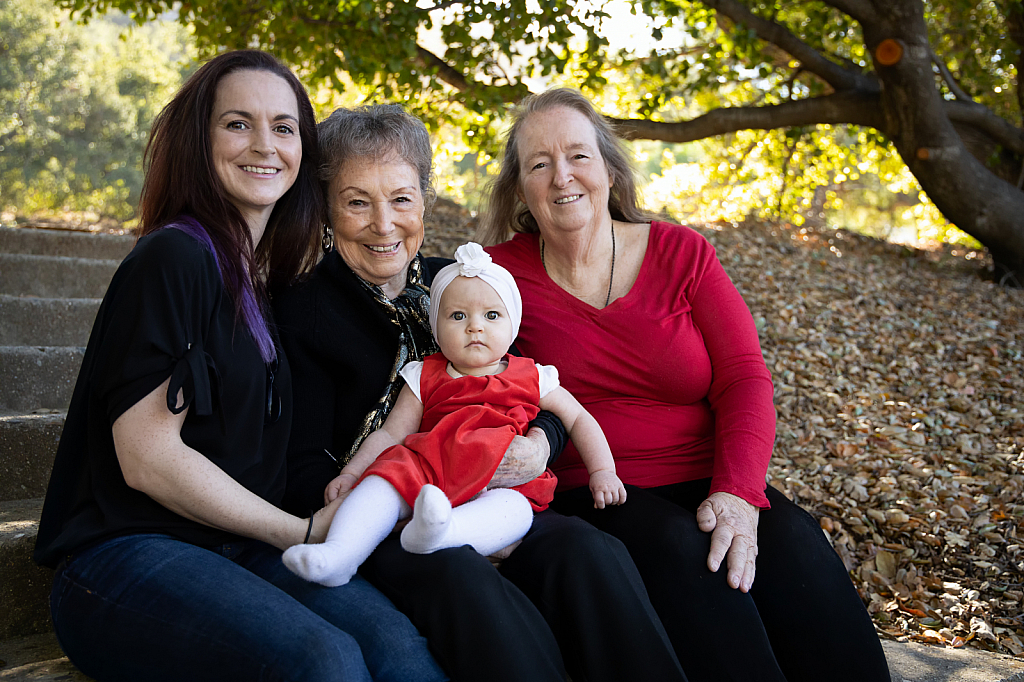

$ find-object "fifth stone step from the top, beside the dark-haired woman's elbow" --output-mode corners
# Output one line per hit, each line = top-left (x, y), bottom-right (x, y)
(0, 413), (65, 502)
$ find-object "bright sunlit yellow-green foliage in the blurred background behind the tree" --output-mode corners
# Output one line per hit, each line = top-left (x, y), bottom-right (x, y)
(0, 0), (983, 247)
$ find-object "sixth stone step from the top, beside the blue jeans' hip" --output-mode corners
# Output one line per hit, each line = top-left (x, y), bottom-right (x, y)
(0, 498), (53, 640)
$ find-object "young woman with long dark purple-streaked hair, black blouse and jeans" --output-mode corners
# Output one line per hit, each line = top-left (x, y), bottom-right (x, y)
(35, 51), (444, 681)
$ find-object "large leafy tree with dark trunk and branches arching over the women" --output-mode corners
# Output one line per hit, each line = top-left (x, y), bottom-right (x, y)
(9, 0), (1024, 278)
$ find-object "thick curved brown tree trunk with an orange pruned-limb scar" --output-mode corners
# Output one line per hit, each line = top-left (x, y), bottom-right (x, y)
(862, 0), (1024, 287)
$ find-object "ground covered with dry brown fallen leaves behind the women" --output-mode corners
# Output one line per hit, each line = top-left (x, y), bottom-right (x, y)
(425, 206), (1024, 655)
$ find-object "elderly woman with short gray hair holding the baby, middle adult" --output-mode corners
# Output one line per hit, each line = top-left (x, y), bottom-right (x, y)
(273, 105), (685, 682)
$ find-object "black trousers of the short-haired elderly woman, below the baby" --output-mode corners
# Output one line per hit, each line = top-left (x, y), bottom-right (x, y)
(360, 510), (686, 682)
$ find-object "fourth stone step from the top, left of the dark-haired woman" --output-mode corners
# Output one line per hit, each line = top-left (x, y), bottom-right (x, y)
(0, 346), (85, 413)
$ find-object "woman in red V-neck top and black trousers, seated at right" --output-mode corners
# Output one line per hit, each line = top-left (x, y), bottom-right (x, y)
(479, 89), (889, 682)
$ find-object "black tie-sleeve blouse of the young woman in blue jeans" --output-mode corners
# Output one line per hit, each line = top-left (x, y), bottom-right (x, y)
(35, 228), (292, 566)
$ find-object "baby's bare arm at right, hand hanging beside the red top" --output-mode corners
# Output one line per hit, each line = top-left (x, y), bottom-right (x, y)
(540, 386), (626, 509)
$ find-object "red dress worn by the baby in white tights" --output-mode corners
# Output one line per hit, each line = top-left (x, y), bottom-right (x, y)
(362, 353), (557, 511)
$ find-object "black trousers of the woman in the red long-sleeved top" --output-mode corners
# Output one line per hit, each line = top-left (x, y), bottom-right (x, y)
(552, 479), (890, 682)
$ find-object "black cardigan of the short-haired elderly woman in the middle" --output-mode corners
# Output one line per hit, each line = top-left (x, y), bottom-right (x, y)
(273, 251), (567, 515)
